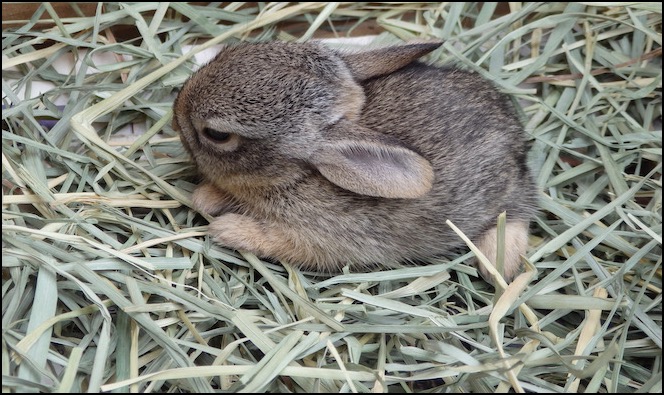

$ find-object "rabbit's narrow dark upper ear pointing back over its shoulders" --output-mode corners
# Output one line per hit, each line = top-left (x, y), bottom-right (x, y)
(339, 41), (443, 81)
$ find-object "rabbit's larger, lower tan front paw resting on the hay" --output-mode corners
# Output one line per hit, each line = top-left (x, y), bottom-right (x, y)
(209, 213), (287, 256)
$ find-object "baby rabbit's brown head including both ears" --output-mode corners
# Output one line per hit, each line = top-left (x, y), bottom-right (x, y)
(174, 42), (440, 198)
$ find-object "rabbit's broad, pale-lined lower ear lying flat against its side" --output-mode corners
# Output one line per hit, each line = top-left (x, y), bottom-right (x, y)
(311, 141), (433, 199)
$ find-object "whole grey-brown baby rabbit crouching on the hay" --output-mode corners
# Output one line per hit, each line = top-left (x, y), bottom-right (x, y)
(174, 42), (536, 279)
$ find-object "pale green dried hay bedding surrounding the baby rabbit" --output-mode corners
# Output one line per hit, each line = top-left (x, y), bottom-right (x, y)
(2, 3), (662, 392)
